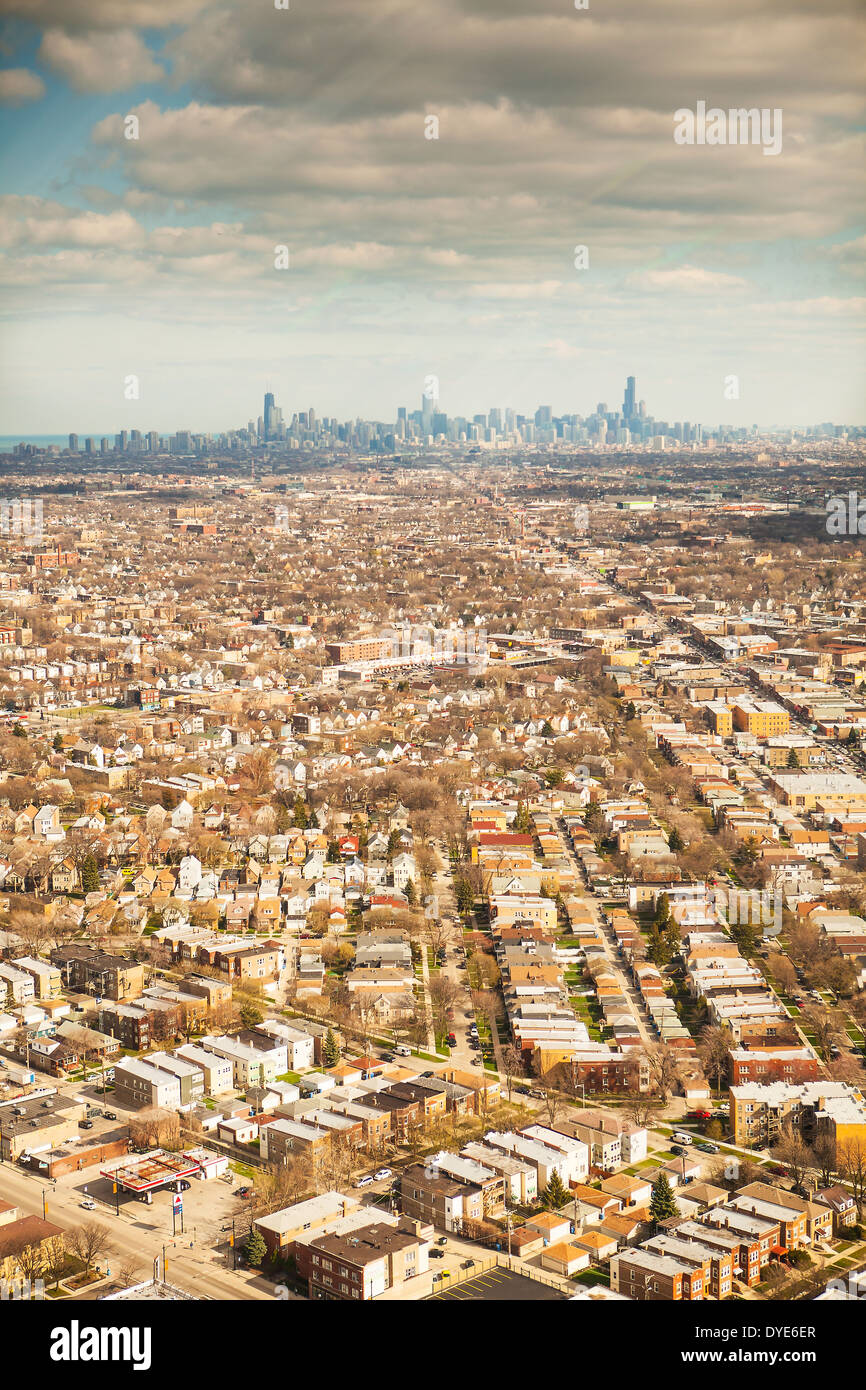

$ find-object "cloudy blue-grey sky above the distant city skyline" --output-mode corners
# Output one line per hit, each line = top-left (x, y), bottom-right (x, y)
(0, 0), (866, 436)
